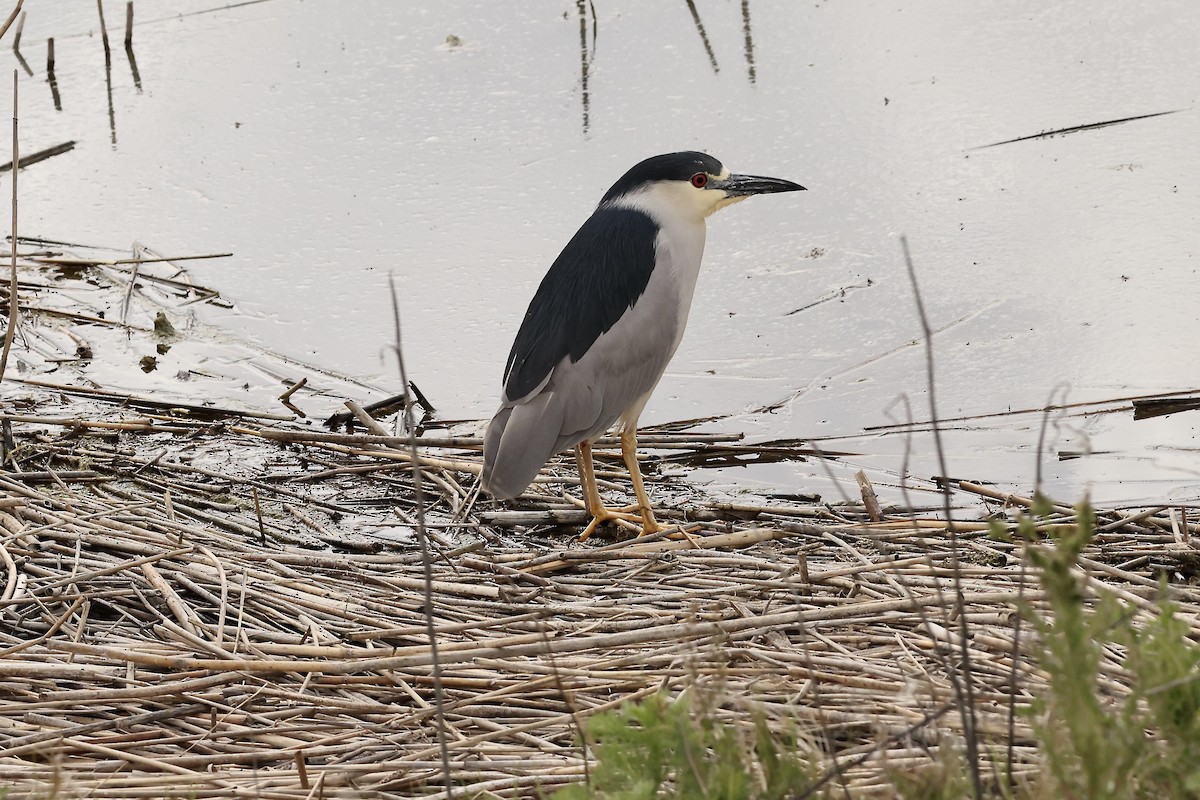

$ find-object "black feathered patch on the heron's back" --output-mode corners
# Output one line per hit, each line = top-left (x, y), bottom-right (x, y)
(504, 207), (659, 403)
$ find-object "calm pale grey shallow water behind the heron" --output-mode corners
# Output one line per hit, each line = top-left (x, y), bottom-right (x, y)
(9, 0), (1200, 503)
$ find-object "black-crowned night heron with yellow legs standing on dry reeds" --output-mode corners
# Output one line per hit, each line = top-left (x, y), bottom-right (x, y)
(482, 152), (804, 539)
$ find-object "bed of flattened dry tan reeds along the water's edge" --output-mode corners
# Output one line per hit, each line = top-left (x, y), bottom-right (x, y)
(0, 242), (1200, 800)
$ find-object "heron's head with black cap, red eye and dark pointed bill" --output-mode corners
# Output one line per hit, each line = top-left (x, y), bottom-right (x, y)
(600, 152), (804, 221)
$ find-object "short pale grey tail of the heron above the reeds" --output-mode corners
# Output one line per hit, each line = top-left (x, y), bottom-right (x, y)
(481, 392), (563, 500)
